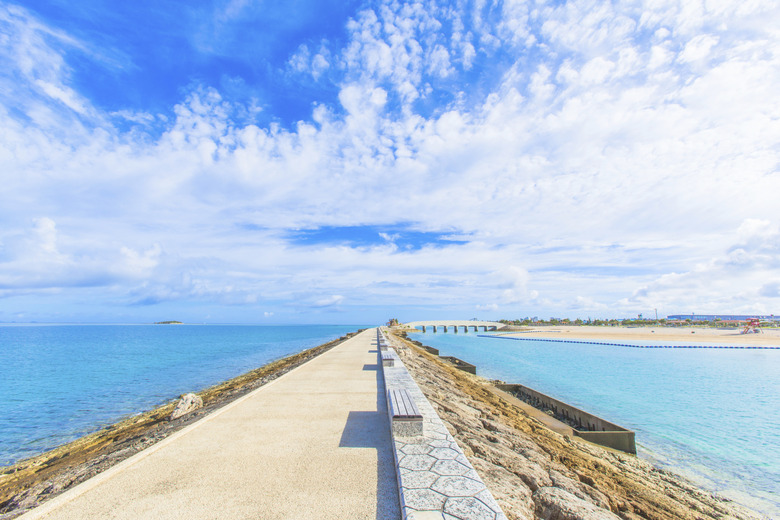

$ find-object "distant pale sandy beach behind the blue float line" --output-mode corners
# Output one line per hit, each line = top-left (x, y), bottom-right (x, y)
(499, 325), (780, 347)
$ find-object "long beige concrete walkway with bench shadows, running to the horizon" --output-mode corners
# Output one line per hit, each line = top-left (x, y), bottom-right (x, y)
(21, 329), (401, 520)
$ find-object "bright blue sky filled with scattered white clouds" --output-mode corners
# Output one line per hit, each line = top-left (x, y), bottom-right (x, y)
(0, 0), (780, 325)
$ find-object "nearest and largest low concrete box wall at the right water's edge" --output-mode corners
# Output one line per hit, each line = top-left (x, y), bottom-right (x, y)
(496, 384), (636, 454)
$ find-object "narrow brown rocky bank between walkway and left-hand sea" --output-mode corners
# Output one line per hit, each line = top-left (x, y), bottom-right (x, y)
(0, 330), (360, 520)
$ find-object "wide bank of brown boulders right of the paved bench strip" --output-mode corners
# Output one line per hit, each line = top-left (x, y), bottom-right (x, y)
(388, 336), (763, 520)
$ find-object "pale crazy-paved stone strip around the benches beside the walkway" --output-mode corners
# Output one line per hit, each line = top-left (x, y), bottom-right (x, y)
(378, 333), (506, 520)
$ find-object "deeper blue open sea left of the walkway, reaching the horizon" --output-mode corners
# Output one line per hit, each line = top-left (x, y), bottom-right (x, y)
(0, 325), (359, 466)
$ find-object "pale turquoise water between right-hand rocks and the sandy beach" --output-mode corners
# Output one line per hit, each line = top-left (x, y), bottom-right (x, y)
(410, 332), (780, 518)
